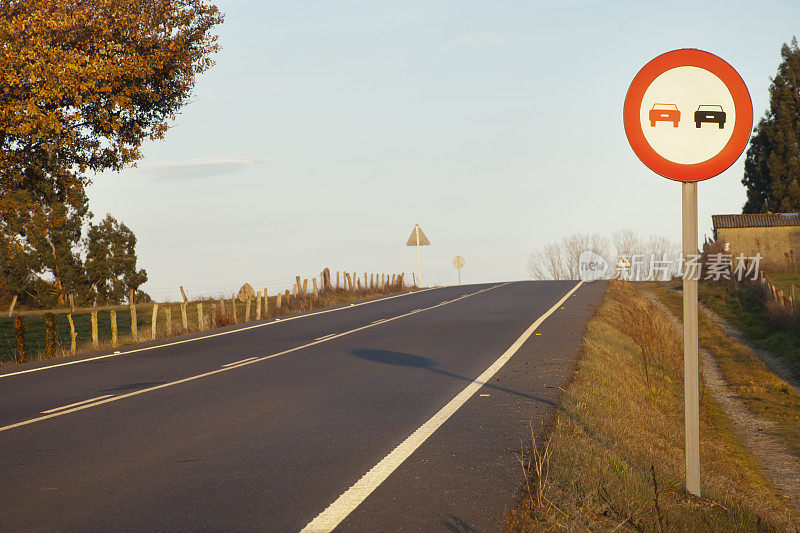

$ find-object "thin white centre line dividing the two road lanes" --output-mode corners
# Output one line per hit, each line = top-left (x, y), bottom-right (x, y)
(0, 283), (508, 432)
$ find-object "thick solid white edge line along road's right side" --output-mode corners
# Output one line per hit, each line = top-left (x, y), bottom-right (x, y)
(300, 281), (583, 533)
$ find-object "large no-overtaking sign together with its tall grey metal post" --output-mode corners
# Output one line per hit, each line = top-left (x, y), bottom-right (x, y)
(623, 49), (753, 496)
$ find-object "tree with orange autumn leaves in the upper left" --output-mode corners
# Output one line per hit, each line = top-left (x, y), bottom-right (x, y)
(0, 0), (223, 306)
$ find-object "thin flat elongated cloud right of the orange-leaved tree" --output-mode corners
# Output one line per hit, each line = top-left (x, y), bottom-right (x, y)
(135, 157), (277, 181)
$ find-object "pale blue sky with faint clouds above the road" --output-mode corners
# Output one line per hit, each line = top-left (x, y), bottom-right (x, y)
(88, 0), (800, 299)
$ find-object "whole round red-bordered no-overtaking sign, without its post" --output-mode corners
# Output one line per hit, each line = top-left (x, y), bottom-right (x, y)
(622, 48), (753, 182)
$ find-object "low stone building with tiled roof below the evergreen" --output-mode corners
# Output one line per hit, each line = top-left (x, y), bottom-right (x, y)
(711, 213), (800, 272)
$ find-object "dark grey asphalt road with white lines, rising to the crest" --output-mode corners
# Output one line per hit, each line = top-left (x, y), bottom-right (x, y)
(0, 281), (605, 532)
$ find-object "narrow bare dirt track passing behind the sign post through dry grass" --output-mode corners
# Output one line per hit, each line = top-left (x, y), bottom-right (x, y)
(643, 291), (800, 509)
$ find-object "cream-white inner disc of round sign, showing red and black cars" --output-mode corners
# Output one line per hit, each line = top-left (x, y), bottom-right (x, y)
(639, 67), (736, 165)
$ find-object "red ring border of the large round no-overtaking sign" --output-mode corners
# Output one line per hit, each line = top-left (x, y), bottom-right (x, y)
(623, 48), (753, 181)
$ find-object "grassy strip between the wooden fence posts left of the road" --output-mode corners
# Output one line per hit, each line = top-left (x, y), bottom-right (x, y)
(0, 284), (416, 366)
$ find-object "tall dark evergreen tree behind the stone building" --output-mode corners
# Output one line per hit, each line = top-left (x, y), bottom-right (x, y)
(742, 38), (800, 213)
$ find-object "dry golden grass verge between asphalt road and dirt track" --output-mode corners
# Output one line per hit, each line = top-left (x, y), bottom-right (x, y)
(506, 282), (798, 531)
